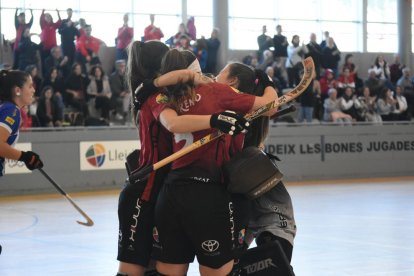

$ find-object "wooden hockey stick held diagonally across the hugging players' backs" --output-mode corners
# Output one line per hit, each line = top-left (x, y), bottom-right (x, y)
(129, 57), (315, 183)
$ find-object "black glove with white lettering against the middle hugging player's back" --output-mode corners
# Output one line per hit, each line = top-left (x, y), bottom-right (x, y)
(210, 110), (249, 135)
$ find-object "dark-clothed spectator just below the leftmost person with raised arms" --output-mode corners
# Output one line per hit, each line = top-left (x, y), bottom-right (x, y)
(17, 28), (40, 71)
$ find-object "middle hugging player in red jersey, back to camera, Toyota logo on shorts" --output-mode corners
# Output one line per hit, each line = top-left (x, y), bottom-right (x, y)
(153, 49), (277, 276)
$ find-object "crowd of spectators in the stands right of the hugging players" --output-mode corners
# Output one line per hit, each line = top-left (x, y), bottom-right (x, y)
(247, 25), (414, 124)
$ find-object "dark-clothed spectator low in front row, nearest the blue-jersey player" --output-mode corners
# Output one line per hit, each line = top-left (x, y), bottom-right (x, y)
(36, 86), (63, 127)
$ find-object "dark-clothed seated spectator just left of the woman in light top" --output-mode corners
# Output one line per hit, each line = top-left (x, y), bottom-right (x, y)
(63, 62), (90, 118)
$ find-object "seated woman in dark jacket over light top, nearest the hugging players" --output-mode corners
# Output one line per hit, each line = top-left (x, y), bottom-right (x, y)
(87, 65), (112, 123)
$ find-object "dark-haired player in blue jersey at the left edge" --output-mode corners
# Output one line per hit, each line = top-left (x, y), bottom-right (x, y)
(0, 70), (43, 177)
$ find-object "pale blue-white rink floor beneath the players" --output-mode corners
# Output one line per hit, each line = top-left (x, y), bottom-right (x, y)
(0, 178), (414, 276)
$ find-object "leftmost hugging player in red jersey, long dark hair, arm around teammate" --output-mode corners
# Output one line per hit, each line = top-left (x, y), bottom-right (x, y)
(117, 41), (247, 276)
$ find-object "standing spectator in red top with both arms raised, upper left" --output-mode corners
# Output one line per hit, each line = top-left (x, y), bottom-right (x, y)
(40, 9), (62, 73)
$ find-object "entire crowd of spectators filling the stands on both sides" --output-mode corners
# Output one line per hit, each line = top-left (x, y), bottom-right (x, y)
(1, 8), (414, 127)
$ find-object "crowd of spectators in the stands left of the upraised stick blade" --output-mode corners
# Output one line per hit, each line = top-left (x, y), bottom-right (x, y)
(1, 8), (220, 127)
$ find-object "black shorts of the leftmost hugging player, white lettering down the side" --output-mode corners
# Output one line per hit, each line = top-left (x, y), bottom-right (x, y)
(117, 182), (155, 267)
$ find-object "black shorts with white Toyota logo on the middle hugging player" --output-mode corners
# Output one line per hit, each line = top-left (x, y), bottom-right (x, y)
(154, 172), (235, 268)
